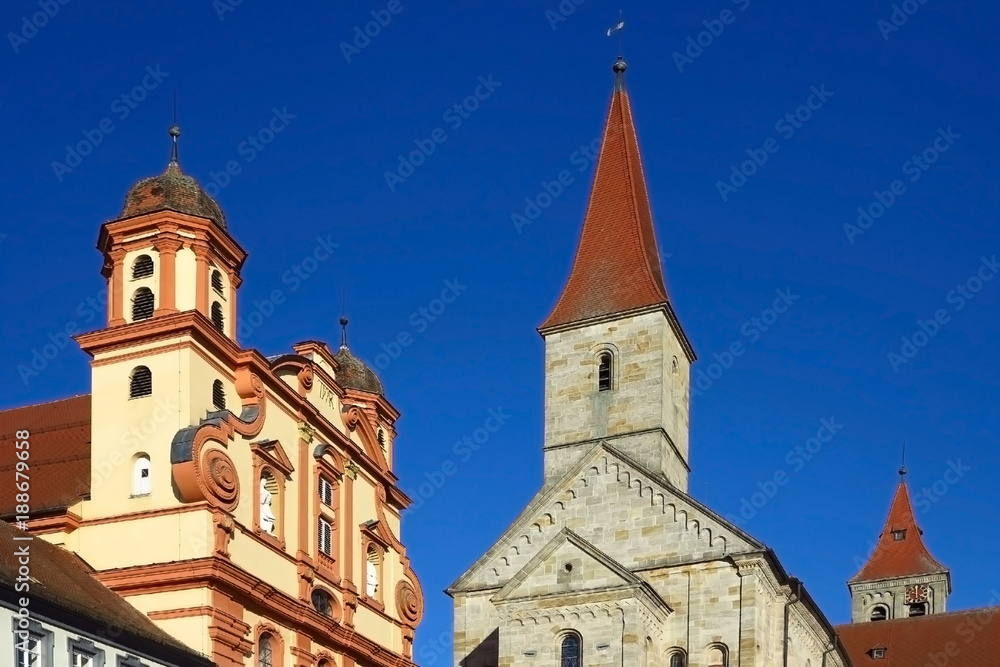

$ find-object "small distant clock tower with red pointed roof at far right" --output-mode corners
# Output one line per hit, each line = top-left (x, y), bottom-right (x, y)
(848, 468), (951, 623)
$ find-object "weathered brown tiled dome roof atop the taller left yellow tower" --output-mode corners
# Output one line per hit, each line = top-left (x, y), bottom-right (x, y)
(120, 161), (226, 229)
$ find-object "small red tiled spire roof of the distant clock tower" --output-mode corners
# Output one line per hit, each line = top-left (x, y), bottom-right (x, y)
(851, 479), (948, 583)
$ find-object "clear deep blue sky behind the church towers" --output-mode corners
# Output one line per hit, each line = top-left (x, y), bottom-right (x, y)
(0, 0), (1000, 665)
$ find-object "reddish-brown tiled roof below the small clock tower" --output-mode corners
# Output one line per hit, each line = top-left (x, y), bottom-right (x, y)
(836, 607), (1000, 667)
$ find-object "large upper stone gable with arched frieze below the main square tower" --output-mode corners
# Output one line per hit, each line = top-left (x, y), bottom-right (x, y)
(452, 443), (763, 591)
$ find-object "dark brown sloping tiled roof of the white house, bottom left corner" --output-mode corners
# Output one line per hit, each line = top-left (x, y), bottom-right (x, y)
(0, 521), (211, 666)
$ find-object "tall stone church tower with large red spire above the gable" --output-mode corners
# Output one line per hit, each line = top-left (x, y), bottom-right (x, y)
(539, 58), (695, 491)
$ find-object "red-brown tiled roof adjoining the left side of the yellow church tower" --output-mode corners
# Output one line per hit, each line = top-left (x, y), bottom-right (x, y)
(0, 395), (90, 517)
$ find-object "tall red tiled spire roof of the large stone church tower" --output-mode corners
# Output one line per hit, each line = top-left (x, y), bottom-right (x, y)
(541, 59), (667, 330)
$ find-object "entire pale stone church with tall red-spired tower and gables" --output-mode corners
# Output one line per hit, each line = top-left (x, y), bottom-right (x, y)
(448, 59), (849, 667)
